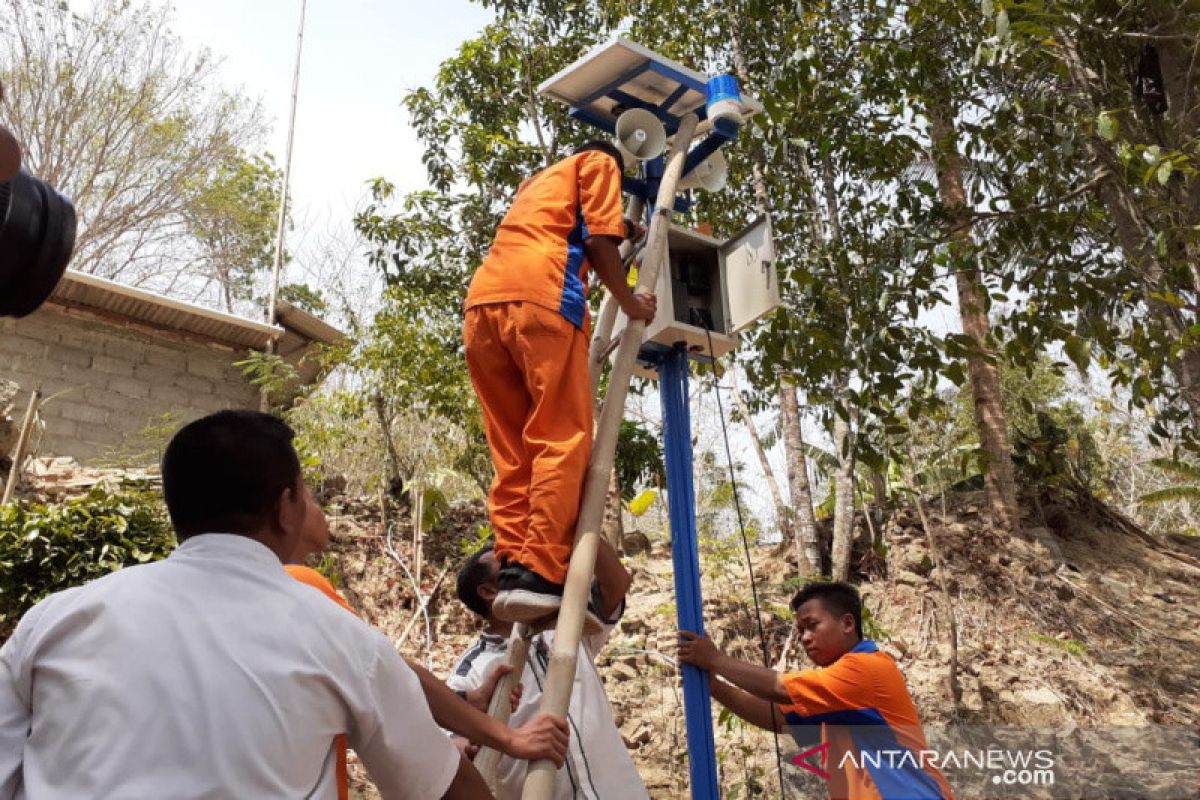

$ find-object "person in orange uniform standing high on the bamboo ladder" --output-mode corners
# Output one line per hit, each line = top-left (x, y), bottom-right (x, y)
(463, 142), (656, 622)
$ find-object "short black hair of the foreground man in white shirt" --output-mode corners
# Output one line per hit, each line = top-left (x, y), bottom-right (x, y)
(162, 410), (301, 540)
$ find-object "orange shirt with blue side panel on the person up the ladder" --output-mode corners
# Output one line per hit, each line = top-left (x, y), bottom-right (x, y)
(467, 150), (625, 329)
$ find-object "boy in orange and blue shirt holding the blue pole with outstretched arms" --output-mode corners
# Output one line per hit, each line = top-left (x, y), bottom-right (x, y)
(679, 583), (953, 800)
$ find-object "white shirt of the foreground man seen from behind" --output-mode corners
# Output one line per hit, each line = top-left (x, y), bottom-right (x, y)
(0, 534), (460, 800)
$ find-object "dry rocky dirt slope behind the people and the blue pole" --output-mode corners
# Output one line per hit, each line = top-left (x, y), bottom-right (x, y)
(325, 494), (1200, 798)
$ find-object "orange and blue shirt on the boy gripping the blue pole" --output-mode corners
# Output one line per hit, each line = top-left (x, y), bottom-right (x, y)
(780, 639), (953, 800)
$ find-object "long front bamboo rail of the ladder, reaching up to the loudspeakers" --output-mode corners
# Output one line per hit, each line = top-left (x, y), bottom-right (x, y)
(521, 114), (696, 800)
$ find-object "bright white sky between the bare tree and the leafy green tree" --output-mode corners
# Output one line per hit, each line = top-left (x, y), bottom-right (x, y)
(173, 0), (491, 223)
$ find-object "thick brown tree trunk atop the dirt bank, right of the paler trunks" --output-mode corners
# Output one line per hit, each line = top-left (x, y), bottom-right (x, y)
(928, 102), (1021, 534)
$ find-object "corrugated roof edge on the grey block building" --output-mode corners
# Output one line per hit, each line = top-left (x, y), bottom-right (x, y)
(49, 270), (346, 383)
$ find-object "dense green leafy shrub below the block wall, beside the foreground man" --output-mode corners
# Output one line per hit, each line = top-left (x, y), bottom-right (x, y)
(0, 488), (175, 638)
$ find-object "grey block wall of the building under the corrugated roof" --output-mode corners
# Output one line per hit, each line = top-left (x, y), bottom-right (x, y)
(0, 307), (258, 470)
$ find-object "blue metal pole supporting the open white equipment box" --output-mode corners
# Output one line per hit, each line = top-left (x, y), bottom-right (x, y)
(659, 347), (721, 800)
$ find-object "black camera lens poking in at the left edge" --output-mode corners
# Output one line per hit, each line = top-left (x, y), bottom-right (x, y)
(0, 169), (76, 317)
